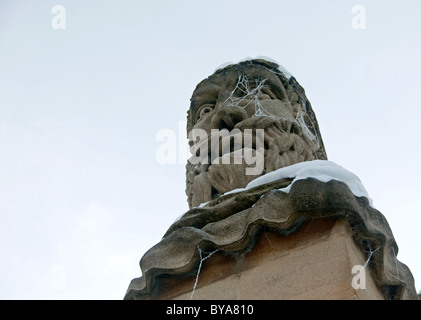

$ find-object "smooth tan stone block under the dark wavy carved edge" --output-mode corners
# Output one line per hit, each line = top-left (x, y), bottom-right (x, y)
(157, 219), (384, 300)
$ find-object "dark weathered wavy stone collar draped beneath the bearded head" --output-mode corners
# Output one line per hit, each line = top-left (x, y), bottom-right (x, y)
(125, 178), (417, 299)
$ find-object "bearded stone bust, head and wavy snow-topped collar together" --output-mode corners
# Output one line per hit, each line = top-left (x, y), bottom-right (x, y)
(125, 59), (418, 300)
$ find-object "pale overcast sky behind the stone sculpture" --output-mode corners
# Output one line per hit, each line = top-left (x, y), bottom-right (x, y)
(0, 0), (421, 299)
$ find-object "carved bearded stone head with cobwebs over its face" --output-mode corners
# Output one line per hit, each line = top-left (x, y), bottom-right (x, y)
(186, 60), (327, 208)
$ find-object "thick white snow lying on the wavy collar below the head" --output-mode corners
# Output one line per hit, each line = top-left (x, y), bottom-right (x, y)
(225, 160), (374, 208)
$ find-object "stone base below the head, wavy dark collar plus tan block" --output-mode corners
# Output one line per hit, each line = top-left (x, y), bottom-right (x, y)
(125, 178), (418, 300)
